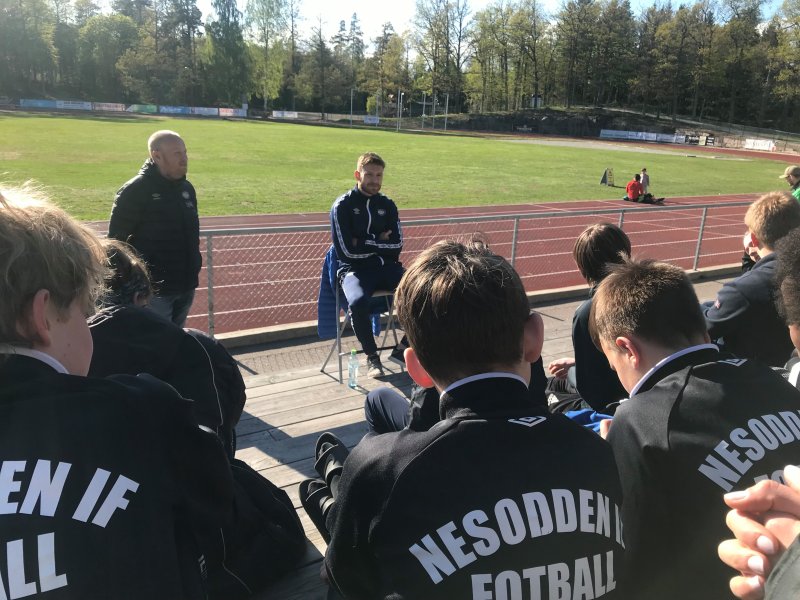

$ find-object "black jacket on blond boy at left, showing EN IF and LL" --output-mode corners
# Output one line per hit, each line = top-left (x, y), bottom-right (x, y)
(0, 356), (233, 600)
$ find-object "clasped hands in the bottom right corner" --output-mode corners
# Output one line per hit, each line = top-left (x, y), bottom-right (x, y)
(718, 465), (800, 600)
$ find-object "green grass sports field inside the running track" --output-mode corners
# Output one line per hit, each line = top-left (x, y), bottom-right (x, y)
(0, 113), (785, 219)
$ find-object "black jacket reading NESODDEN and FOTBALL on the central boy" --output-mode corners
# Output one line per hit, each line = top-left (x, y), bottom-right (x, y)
(325, 376), (624, 600)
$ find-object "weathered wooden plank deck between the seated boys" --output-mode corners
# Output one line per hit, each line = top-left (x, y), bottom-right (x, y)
(236, 362), (411, 600)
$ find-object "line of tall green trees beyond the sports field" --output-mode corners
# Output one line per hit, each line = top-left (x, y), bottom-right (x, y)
(0, 0), (800, 129)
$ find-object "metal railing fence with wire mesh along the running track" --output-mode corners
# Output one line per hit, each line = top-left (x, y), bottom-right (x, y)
(188, 201), (750, 335)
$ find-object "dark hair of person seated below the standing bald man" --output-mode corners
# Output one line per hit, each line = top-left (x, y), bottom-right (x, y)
(101, 238), (153, 306)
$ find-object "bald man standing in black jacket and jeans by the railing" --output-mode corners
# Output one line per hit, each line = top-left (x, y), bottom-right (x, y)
(108, 130), (202, 327)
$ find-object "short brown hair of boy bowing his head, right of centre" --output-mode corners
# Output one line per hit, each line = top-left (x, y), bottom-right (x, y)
(589, 259), (706, 350)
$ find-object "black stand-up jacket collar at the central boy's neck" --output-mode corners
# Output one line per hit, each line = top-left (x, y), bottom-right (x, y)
(439, 373), (545, 419)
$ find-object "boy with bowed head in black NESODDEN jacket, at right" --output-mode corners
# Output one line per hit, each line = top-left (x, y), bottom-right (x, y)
(590, 260), (800, 600)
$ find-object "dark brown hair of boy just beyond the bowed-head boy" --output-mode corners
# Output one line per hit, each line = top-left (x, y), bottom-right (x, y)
(572, 223), (631, 285)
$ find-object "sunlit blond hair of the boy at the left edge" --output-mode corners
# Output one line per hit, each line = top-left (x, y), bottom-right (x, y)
(0, 186), (105, 345)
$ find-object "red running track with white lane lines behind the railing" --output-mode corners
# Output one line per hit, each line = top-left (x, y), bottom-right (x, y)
(166, 194), (756, 333)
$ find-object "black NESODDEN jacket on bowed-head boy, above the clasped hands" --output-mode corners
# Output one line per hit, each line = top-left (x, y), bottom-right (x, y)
(608, 345), (800, 600)
